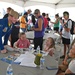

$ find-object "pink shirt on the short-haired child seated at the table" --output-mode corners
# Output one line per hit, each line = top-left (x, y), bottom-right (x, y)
(16, 39), (30, 48)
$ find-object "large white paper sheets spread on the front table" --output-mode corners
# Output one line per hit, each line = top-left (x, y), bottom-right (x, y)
(14, 52), (36, 67)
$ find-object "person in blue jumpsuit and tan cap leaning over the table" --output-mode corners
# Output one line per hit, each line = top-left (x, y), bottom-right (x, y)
(0, 9), (19, 53)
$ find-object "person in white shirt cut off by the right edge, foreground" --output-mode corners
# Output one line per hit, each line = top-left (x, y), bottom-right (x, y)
(57, 43), (75, 75)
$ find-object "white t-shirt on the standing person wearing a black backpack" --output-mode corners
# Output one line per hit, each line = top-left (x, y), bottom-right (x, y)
(62, 20), (72, 39)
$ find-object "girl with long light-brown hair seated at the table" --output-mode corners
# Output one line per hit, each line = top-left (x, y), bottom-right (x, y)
(44, 37), (55, 56)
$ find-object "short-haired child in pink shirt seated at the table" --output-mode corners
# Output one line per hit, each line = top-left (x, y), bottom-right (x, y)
(14, 32), (30, 48)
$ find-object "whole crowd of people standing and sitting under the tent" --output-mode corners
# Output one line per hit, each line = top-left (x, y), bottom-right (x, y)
(0, 7), (75, 75)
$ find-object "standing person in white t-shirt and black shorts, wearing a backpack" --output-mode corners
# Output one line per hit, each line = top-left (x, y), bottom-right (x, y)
(61, 11), (72, 58)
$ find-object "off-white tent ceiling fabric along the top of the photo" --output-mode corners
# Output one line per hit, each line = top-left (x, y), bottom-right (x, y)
(0, 0), (75, 8)
